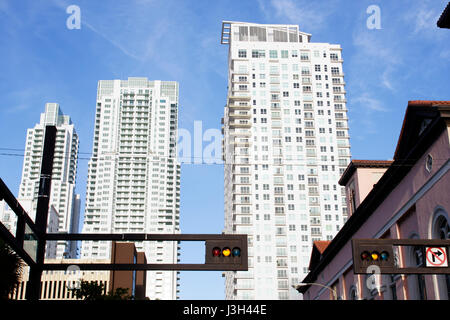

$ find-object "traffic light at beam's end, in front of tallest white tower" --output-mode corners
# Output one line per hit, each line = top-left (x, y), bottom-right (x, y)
(205, 238), (248, 270)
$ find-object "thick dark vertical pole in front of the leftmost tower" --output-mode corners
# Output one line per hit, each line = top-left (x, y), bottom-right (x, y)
(26, 126), (56, 300)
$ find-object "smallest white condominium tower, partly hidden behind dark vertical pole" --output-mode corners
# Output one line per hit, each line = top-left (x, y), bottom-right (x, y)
(18, 103), (80, 258)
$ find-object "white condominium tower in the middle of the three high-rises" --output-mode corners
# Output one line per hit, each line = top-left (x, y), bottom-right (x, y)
(81, 78), (180, 300)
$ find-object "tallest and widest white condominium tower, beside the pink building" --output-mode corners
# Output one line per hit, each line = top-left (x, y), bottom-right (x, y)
(221, 21), (350, 299)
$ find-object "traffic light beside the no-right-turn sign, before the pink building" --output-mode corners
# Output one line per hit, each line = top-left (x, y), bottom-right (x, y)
(352, 239), (394, 273)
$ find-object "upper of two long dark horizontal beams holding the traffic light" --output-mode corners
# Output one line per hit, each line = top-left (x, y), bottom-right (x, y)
(46, 233), (247, 241)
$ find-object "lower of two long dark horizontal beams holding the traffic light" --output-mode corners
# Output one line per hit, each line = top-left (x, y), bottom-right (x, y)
(43, 263), (247, 271)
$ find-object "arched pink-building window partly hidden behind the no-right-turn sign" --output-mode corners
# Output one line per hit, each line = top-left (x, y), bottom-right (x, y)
(431, 208), (450, 300)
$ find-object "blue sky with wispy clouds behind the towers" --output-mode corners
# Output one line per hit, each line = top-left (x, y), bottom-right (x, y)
(0, 0), (450, 299)
